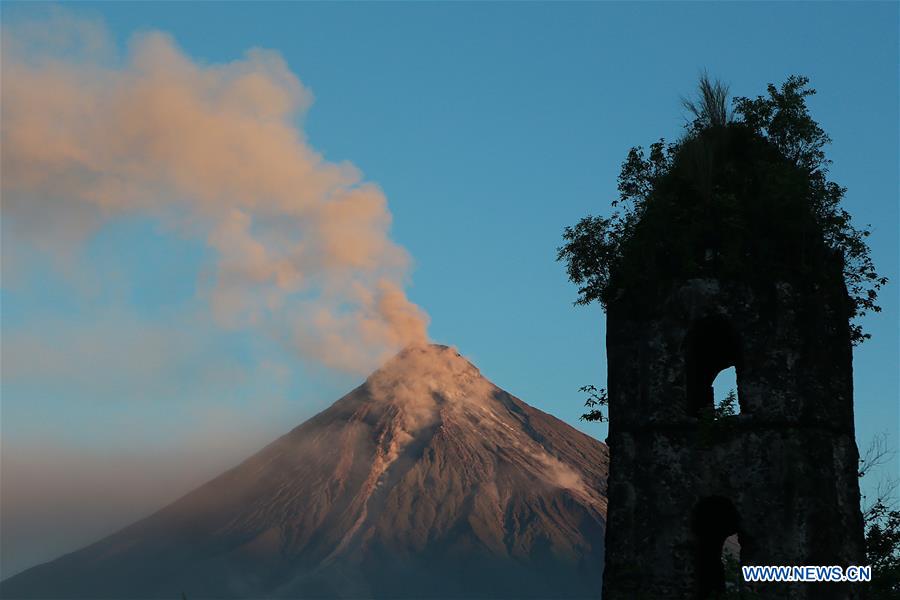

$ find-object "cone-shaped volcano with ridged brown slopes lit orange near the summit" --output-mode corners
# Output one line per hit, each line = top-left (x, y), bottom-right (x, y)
(0, 345), (609, 600)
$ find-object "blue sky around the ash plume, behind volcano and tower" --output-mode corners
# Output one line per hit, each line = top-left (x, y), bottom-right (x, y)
(2, 2), (900, 576)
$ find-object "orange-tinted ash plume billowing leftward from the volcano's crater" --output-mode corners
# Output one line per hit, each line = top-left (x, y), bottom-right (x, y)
(2, 11), (428, 372)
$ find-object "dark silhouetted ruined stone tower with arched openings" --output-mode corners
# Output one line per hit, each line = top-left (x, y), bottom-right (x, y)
(603, 124), (865, 600)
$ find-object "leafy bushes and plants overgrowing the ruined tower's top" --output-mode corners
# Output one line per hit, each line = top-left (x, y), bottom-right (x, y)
(557, 75), (887, 344)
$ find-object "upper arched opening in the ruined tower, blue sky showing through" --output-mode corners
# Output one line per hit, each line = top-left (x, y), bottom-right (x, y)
(685, 317), (741, 415)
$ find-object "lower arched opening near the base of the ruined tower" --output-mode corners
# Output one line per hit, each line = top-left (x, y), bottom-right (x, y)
(692, 496), (740, 600)
